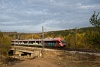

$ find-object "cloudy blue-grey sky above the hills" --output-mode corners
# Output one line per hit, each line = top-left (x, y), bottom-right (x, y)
(0, 0), (100, 33)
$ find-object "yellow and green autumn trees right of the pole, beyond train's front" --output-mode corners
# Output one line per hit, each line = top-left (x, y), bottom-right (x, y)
(45, 27), (100, 49)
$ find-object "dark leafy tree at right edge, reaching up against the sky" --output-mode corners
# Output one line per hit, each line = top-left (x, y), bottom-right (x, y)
(89, 11), (100, 48)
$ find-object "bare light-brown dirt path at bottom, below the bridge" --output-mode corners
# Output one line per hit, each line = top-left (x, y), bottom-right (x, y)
(6, 58), (59, 67)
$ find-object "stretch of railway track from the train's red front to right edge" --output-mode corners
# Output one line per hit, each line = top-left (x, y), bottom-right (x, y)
(54, 48), (100, 57)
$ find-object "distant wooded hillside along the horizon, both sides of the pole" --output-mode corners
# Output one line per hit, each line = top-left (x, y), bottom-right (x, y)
(2, 27), (95, 38)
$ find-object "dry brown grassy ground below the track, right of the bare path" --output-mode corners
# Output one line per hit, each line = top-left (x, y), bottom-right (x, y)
(45, 51), (100, 67)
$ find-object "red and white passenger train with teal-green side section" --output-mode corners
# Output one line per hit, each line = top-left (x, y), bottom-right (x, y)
(11, 38), (67, 47)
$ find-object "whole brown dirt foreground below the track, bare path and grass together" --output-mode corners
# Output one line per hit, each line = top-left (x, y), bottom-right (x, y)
(0, 51), (100, 67)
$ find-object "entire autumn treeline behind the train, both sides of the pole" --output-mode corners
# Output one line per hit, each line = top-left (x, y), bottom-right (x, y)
(4, 27), (100, 49)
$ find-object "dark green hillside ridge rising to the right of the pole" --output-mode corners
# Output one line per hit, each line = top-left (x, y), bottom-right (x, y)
(46, 27), (95, 37)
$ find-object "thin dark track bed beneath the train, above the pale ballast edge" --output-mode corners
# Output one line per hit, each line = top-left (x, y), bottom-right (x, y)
(11, 46), (100, 53)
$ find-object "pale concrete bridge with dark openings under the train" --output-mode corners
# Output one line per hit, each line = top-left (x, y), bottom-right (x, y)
(10, 46), (43, 58)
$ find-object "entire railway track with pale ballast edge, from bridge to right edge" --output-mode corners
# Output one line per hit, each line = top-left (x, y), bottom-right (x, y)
(10, 46), (100, 56)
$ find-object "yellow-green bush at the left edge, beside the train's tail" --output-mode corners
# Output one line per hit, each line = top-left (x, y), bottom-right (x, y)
(0, 32), (11, 61)
